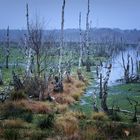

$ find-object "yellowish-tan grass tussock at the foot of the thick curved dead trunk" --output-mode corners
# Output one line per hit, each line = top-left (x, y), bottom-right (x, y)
(92, 112), (108, 121)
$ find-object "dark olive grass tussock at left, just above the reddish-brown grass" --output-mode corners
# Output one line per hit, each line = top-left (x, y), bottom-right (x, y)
(11, 90), (27, 101)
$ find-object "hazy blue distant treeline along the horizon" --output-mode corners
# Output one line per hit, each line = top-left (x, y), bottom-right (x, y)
(0, 28), (140, 44)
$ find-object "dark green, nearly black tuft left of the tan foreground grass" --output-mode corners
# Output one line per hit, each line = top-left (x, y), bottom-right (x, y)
(37, 114), (54, 129)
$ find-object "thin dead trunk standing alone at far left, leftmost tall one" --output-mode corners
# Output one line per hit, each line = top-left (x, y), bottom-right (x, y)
(6, 26), (10, 69)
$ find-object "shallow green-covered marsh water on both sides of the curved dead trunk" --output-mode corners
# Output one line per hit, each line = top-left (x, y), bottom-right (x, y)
(72, 64), (140, 116)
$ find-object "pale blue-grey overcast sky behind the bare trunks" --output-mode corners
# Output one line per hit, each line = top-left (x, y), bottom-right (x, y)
(0, 0), (140, 29)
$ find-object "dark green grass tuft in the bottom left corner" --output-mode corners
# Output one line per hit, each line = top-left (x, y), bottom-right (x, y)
(4, 129), (20, 140)
